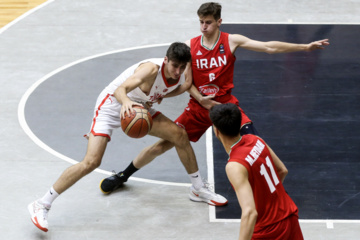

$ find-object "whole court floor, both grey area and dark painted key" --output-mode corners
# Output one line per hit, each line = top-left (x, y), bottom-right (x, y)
(0, 0), (360, 240)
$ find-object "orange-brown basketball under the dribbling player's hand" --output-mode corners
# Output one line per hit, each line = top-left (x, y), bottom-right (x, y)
(121, 106), (152, 138)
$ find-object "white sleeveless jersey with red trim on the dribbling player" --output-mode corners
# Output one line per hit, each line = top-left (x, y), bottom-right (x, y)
(105, 58), (185, 103)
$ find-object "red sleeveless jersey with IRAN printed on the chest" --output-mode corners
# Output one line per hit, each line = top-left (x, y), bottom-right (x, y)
(190, 32), (236, 102)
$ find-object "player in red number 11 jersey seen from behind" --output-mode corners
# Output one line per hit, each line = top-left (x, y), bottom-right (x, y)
(210, 103), (304, 240)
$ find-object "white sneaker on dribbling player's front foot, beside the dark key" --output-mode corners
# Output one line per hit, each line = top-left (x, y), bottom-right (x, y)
(189, 186), (228, 206)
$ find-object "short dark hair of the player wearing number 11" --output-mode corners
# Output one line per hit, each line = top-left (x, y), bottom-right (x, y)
(209, 103), (241, 137)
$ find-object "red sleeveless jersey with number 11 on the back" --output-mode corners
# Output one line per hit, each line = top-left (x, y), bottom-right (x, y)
(228, 134), (298, 233)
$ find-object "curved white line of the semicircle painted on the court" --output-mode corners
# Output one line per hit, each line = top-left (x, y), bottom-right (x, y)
(18, 43), (191, 187)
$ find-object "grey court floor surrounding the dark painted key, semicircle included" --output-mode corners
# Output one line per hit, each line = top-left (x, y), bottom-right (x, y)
(0, 0), (360, 240)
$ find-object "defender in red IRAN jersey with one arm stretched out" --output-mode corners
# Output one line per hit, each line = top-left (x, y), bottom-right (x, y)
(104, 2), (329, 202)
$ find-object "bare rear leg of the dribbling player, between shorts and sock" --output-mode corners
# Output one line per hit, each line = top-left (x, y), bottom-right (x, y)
(53, 134), (108, 194)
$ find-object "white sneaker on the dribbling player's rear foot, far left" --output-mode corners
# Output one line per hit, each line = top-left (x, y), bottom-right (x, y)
(28, 200), (50, 232)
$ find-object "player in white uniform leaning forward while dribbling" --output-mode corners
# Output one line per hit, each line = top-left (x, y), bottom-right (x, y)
(28, 43), (227, 232)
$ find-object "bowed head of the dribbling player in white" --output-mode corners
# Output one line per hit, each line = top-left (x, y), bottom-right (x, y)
(164, 42), (191, 79)
